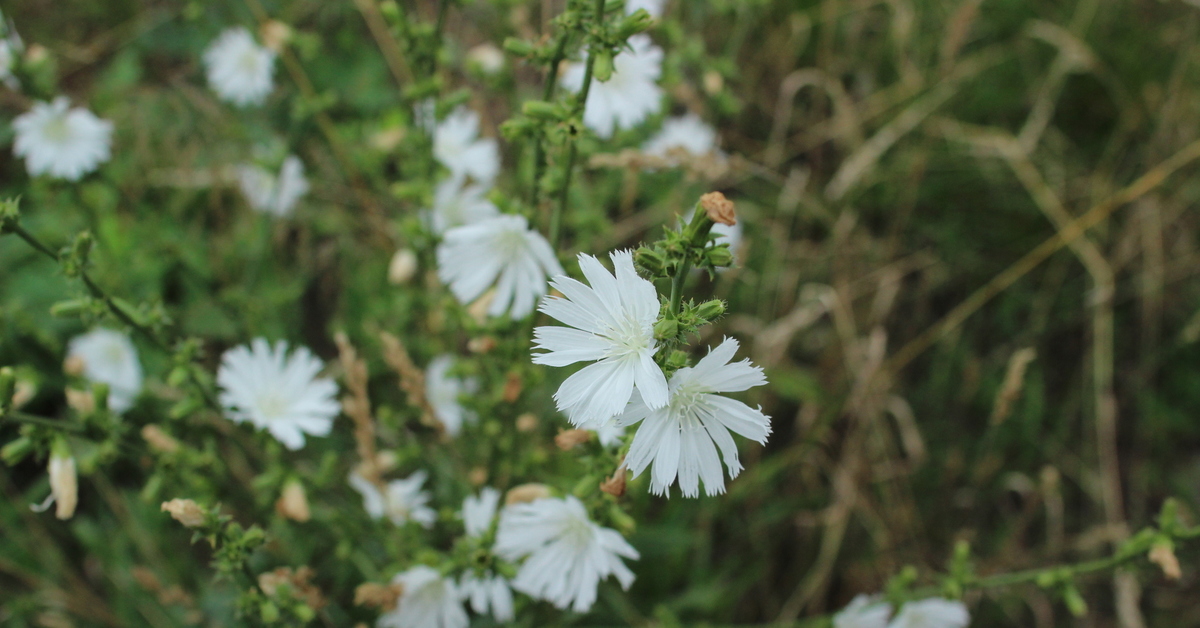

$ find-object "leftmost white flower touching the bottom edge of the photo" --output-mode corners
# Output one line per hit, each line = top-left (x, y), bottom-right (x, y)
(376, 564), (470, 628)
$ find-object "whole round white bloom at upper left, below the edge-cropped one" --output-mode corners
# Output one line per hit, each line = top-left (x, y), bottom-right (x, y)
(12, 96), (113, 181)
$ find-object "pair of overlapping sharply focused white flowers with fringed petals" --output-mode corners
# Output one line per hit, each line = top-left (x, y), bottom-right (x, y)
(534, 251), (770, 497)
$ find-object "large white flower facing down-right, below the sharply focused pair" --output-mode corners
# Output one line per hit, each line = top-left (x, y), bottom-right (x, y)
(496, 496), (638, 612)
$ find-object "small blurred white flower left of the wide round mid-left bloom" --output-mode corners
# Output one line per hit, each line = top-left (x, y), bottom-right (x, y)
(67, 329), (142, 414)
